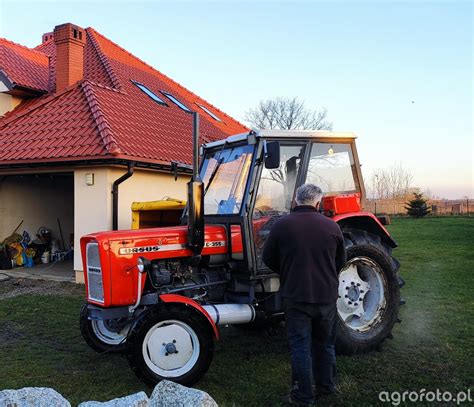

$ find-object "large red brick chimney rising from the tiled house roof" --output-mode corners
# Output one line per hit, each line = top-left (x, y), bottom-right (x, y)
(54, 23), (86, 92)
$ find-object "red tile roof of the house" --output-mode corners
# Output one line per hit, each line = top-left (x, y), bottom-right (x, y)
(0, 28), (248, 166)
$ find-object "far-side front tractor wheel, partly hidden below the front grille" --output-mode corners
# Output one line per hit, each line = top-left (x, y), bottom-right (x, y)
(79, 304), (130, 353)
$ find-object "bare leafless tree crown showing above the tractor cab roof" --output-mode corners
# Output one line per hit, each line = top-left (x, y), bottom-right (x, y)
(245, 97), (332, 130)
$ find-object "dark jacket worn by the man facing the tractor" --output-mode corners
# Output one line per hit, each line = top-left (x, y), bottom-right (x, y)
(262, 205), (346, 304)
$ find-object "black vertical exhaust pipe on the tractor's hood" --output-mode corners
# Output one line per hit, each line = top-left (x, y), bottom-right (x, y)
(188, 112), (204, 256)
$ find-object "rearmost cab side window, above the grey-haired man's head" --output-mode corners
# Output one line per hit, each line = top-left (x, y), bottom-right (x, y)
(305, 143), (357, 195)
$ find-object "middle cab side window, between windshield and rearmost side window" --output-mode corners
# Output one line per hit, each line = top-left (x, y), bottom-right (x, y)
(253, 145), (304, 269)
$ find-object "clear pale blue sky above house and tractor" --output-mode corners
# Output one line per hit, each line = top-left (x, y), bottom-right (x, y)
(0, 0), (474, 198)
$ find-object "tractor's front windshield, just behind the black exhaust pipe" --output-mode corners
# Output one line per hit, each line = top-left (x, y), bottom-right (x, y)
(201, 145), (254, 215)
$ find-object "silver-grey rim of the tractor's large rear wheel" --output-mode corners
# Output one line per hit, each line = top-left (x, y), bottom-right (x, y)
(337, 257), (387, 332)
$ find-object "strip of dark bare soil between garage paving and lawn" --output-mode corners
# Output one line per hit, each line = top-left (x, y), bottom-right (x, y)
(0, 275), (84, 301)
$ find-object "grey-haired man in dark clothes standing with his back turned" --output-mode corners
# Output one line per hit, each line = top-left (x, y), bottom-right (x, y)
(262, 184), (346, 406)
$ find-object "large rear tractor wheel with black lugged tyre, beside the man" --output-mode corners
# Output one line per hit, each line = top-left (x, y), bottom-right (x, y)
(336, 229), (402, 355)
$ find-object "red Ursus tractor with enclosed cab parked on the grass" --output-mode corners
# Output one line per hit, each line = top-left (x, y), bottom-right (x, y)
(80, 114), (403, 385)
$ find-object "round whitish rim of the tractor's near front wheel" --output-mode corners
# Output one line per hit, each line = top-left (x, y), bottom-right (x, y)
(142, 320), (200, 378)
